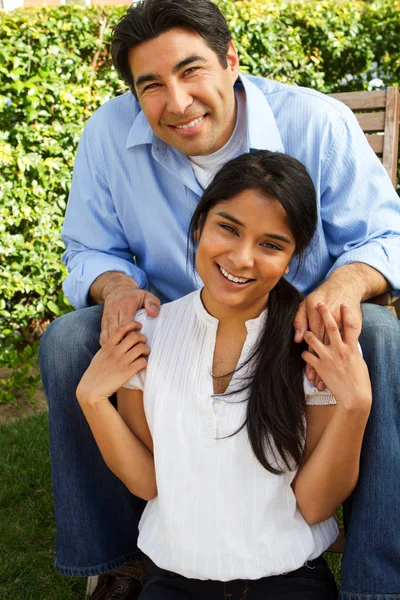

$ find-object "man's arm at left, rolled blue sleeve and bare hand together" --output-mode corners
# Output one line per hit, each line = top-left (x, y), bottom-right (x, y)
(63, 128), (160, 345)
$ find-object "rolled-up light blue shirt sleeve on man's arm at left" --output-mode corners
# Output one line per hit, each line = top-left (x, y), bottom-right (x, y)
(62, 121), (148, 308)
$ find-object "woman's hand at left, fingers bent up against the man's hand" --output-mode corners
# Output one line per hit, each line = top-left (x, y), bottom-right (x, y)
(76, 322), (150, 404)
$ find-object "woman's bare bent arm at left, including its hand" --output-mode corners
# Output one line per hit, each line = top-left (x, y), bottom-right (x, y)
(76, 324), (157, 500)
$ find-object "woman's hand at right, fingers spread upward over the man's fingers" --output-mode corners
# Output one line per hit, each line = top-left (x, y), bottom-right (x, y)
(302, 302), (372, 411)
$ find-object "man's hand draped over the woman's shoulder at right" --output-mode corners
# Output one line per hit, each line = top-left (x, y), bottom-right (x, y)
(293, 263), (389, 390)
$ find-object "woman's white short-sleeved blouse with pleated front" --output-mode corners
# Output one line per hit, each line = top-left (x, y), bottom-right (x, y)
(125, 291), (338, 581)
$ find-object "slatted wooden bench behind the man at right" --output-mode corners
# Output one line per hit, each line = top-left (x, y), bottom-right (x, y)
(329, 86), (400, 552)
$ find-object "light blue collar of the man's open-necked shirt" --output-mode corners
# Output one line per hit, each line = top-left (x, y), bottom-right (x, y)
(126, 74), (284, 152)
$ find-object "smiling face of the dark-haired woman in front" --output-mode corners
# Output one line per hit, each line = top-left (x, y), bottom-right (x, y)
(196, 190), (295, 319)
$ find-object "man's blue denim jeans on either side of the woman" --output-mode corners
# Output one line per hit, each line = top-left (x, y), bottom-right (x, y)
(39, 304), (400, 600)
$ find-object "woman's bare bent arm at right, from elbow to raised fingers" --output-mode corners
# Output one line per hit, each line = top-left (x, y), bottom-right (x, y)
(293, 303), (372, 524)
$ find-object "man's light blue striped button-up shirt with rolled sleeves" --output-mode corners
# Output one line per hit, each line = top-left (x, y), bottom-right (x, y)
(62, 76), (400, 308)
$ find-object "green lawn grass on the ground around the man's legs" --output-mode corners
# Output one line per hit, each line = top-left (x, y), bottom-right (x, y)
(0, 413), (341, 600)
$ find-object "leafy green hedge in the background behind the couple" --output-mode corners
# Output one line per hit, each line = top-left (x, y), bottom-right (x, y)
(0, 0), (400, 402)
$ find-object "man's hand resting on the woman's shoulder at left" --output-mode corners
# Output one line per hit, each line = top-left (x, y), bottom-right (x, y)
(90, 272), (160, 346)
